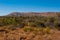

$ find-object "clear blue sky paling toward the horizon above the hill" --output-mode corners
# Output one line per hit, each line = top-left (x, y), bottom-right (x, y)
(0, 0), (60, 16)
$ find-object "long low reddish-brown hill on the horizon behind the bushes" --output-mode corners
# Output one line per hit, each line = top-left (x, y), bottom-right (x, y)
(7, 12), (60, 17)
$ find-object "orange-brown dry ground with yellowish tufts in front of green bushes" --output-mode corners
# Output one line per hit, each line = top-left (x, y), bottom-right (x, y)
(0, 27), (60, 40)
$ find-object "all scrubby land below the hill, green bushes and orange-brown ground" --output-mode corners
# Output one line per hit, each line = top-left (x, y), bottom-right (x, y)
(0, 14), (60, 40)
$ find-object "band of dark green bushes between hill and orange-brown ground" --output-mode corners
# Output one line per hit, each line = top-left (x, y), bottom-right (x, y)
(0, 14), (60, 28)
